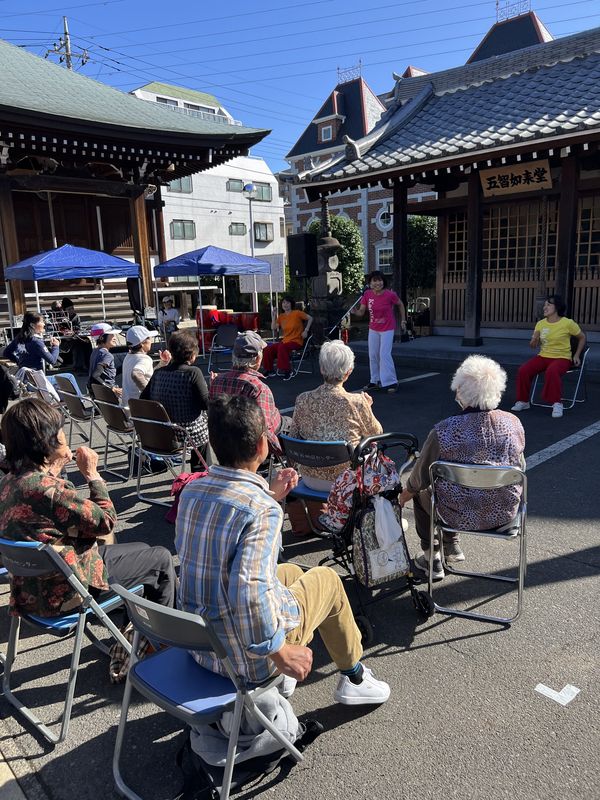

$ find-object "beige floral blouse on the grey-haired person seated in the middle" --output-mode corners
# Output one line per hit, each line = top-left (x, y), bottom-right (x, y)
(289, 383), (383, 481)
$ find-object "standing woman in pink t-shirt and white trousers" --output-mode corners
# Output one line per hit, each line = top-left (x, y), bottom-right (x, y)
(356, 271), (406, 393)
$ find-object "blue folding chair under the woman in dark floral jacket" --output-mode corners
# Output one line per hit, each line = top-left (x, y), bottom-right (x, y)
(0, 539), (135, 744)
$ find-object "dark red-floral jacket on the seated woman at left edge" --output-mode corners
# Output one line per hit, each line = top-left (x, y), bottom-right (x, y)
(0, 470), (117, 617)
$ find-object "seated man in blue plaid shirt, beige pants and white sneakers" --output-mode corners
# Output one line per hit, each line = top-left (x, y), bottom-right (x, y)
(175, 396), (390, 705)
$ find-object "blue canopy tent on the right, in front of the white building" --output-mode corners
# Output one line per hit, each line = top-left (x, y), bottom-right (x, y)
(154, 245), (271, 356)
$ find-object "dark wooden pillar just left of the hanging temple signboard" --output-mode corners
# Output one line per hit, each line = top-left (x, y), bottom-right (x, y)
(462, 170), (483, 347)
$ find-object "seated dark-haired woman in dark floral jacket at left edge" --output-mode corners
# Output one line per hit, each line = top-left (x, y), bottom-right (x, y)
(0, 398), (176, 617)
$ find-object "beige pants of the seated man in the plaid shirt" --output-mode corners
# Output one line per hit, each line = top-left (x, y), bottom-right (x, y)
(277, 564), (363, 670)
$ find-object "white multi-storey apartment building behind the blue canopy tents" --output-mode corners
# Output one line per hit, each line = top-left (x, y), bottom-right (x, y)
(132, 83), (285, 266)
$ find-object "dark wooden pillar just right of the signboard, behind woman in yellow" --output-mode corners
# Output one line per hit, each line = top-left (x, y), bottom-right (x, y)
(555, 156), (579, 309)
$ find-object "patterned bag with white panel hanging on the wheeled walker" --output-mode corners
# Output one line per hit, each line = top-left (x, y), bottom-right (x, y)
(352, 500), (410, 589)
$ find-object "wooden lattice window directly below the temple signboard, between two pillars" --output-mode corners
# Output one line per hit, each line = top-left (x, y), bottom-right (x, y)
(482, 200), (558, 274)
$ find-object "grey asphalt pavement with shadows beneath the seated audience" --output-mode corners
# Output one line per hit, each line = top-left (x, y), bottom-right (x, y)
(0, 366), (600, 800)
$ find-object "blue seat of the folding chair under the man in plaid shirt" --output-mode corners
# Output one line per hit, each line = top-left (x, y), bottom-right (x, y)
(130, 647), (236, 717)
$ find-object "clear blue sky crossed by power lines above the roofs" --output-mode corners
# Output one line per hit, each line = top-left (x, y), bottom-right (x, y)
(0, 0), (600, 170)
